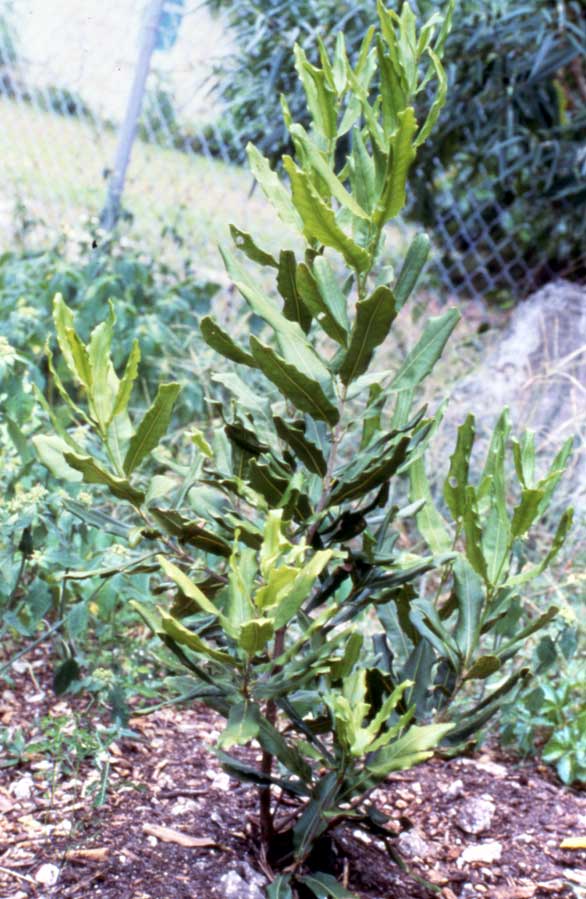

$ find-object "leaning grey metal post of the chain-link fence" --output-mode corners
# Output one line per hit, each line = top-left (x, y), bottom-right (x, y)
(100, 0), (165, 231)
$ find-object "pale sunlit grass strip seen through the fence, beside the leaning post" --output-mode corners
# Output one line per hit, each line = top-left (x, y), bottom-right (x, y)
(0, 98), (291, 270)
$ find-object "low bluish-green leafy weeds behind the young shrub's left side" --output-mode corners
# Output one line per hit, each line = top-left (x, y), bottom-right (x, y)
(0, 239), (216, 715)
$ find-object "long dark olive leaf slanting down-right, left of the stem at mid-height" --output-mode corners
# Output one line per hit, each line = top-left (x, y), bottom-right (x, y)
(250, 335), (339, 426)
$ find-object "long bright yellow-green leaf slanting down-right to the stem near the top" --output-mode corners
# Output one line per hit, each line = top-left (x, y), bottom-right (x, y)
(283, 156), (370, 272)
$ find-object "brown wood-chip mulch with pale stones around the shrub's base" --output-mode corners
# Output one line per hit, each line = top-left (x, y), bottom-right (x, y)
(0, 651), (586, 899)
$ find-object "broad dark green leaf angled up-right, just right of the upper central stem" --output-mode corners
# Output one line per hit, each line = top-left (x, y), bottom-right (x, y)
(339, 287), (396, 384)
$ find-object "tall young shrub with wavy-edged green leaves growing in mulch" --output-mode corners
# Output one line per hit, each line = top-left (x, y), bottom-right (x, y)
(36, 3), (571, 899)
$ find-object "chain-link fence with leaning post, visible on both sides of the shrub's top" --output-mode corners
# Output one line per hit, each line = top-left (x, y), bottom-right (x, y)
(0, 0), (580, 296)
